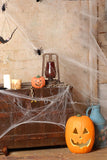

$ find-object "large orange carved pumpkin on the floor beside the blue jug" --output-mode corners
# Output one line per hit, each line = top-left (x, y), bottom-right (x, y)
(65, 115), (95, 153)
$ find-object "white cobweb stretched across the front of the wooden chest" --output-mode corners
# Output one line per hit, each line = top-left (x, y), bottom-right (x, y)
(0, 86), (72, 138)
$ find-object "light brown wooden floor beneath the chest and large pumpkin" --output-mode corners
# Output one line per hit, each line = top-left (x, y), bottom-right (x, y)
(0, 148), (107, 160)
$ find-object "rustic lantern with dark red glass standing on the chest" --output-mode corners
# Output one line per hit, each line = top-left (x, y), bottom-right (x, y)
(42, 53), (60, 84)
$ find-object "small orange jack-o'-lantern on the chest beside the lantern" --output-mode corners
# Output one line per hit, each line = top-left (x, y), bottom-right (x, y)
(31, 75), (45, 88)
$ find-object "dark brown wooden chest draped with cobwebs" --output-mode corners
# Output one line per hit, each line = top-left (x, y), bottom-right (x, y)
(0, 86), (73, 154)
